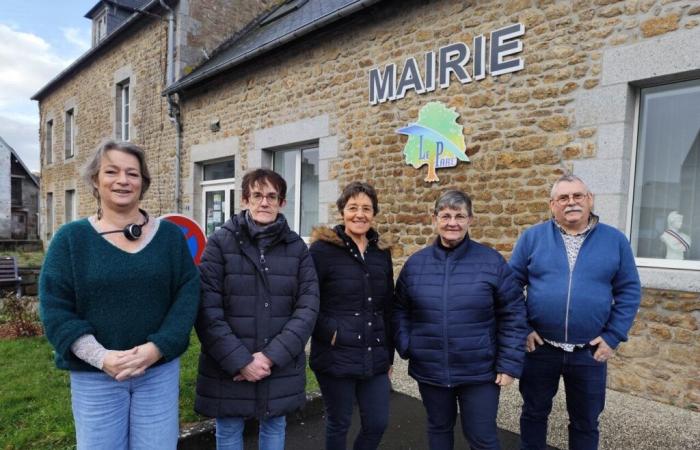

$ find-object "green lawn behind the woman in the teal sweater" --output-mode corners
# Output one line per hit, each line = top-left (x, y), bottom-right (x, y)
(0, 333), (318, 450)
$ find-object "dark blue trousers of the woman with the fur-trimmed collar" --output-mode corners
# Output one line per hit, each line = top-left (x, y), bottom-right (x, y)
(316, 372), (390, 450)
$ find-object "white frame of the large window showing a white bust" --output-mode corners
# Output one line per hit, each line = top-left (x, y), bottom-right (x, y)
(625, 82), (700, 270)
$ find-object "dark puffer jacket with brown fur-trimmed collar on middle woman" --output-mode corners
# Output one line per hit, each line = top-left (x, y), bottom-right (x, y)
(310, 225), (394, 378)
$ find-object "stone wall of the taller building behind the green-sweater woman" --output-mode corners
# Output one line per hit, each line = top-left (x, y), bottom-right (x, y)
(40, 19), (175, 230)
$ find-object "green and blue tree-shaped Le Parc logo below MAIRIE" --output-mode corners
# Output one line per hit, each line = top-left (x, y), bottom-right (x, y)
(396, 102), (469, 183)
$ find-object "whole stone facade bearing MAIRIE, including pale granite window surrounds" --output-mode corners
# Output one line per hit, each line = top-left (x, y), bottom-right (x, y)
(167, 0), (700, 410)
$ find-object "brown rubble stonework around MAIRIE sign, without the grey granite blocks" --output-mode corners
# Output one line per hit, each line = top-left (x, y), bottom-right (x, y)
(176, 0), (700, 408)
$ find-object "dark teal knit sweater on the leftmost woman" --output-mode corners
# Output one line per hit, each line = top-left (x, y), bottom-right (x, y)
(39, 219), (199, 371)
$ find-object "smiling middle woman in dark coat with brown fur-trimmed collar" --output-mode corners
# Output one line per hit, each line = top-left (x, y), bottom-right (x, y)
(310, 182), (394, 450)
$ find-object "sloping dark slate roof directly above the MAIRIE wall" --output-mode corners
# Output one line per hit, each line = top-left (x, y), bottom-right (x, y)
(165, 0), (380, 94)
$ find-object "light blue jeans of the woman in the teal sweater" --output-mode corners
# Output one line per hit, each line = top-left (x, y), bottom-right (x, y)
(70, 359), (180, 450)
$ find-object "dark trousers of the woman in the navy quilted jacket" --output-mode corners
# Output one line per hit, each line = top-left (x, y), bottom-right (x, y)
(418, 383), (501, 450)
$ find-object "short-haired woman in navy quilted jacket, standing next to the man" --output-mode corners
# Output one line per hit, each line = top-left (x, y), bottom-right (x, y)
(392, 191), (527, 450)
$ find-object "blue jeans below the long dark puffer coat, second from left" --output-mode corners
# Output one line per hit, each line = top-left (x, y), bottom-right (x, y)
(216, 416), (287, 450)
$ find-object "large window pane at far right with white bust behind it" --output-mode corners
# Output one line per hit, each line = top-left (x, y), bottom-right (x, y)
(631, 80), (700, 261)
